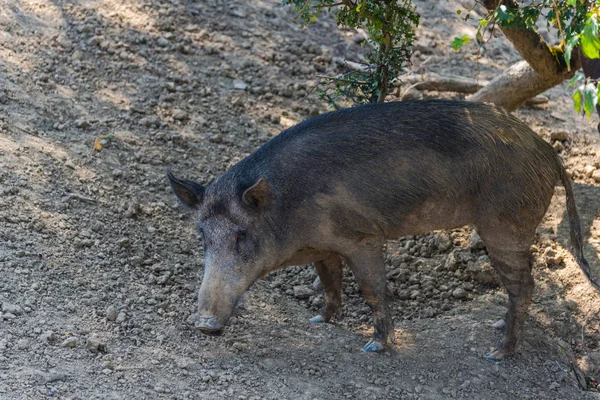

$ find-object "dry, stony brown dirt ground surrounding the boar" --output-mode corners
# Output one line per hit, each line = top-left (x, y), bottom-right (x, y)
(0, 0), (600, 400)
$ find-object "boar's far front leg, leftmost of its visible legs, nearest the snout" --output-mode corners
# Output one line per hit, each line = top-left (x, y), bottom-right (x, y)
(309, 254), (343, 323)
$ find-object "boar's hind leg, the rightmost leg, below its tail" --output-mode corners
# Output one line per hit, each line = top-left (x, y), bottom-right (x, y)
(482, 242), (534, 361)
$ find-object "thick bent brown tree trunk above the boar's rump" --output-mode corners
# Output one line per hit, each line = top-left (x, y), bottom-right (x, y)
(468, 0), (580, 111)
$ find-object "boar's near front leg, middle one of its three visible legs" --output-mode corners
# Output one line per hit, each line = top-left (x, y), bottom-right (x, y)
(345, 243), (395, 352)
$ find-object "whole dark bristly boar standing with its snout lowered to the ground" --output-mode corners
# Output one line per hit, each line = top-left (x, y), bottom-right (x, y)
(169, 100), (598, 359)
